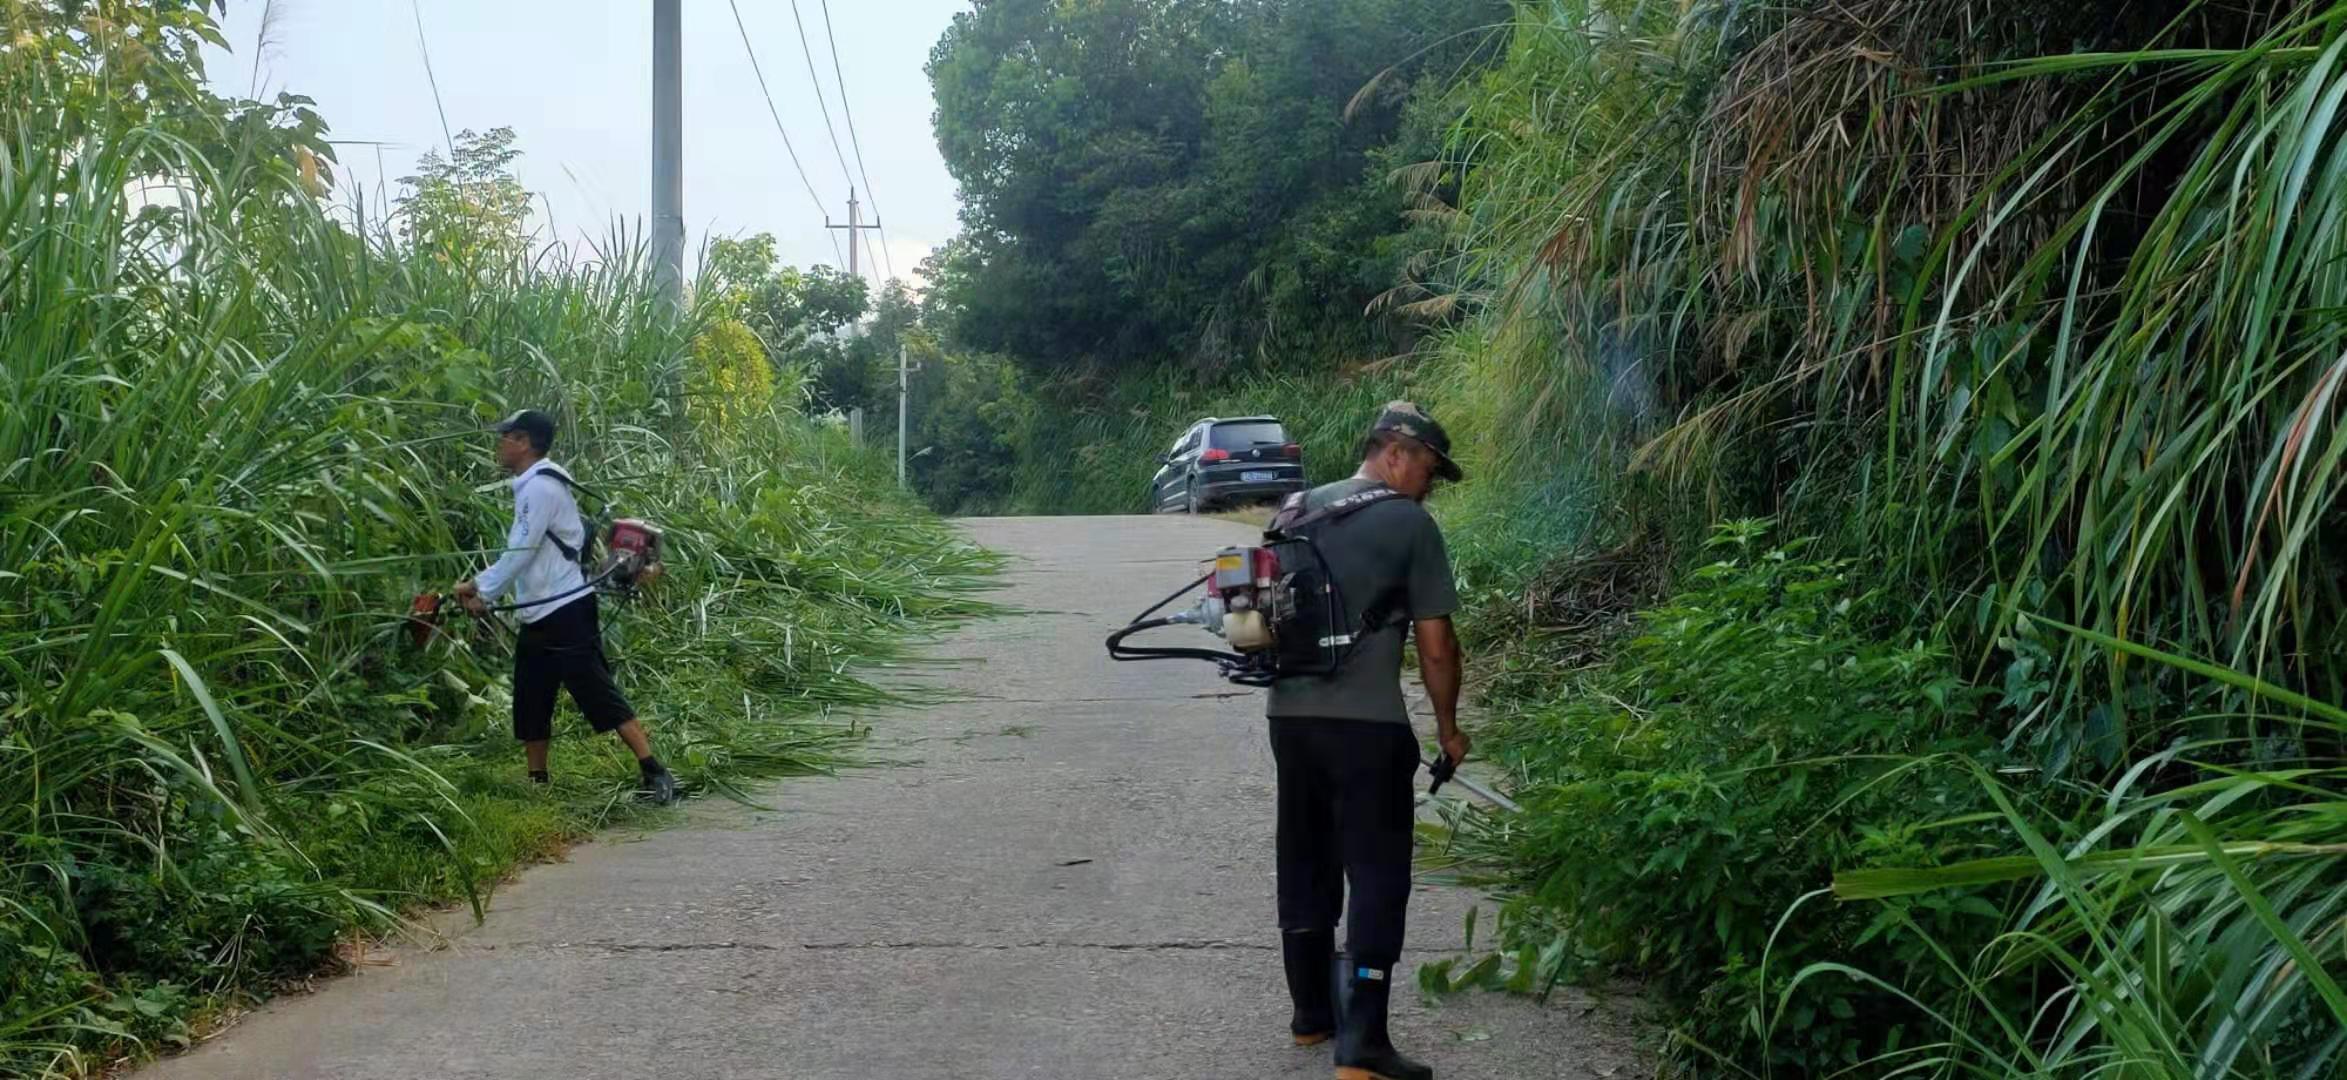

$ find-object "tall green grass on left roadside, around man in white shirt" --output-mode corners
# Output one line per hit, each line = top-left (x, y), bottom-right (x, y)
(0, 73), (990, 1075)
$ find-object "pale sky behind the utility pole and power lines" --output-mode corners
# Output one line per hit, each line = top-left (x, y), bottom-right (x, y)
(207, 0), (969, 284)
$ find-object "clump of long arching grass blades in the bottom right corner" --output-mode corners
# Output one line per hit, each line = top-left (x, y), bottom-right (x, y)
(1786, 718), (2347, 1078)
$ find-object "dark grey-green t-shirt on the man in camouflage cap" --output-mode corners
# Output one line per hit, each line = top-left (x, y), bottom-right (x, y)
(1265, 479), (1460, 723)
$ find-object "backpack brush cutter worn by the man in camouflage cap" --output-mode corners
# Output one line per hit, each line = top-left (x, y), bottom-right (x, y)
(1108, 486), (1521, 812)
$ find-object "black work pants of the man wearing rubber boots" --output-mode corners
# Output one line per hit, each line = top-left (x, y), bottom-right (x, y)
(1272, 716), (1418, 967)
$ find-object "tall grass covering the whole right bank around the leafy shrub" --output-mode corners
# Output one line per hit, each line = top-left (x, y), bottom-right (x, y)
(1411, 0), (2347, 1075)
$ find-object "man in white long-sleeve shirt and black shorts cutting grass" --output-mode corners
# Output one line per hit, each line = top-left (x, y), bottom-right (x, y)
(455, 409), (676, 805)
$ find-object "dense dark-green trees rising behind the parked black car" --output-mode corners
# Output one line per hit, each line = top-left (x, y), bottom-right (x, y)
(929, 0), (1507, 369)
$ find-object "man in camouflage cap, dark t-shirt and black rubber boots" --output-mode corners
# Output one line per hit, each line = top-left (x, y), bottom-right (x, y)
(1265, 401), (1467, 1080)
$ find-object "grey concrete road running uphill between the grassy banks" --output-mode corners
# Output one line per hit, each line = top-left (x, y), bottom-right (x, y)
(143, 517), (1645, 1080)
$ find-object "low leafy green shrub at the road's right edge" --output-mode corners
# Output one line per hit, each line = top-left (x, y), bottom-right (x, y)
(1427, 521), (2002, 1071)
